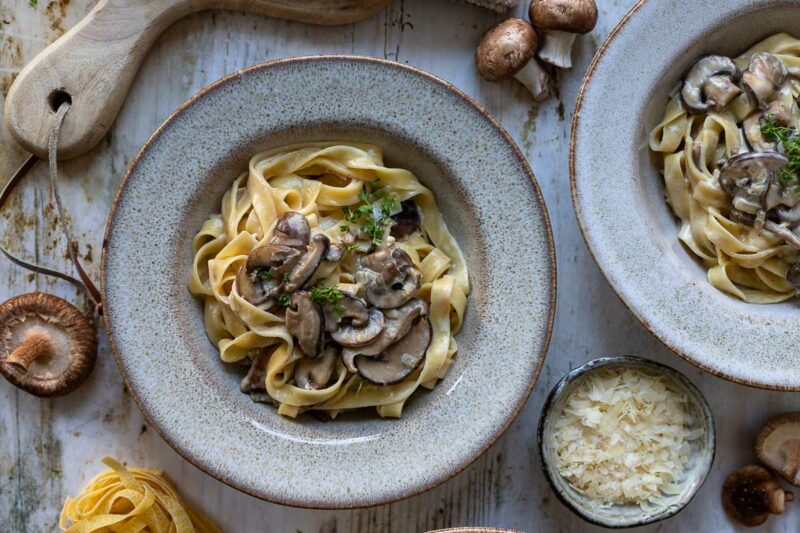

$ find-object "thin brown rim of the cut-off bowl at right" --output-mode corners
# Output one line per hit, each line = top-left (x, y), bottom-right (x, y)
(569, 0), (800, 392)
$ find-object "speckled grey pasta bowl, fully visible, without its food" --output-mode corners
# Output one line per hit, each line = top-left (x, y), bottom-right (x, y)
(103, 56), (555, 508)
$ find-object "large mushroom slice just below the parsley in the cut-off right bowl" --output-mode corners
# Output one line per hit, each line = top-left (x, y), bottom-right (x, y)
(719, 152), (788, 215)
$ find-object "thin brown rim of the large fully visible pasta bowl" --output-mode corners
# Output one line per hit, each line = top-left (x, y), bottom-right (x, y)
(100, 54), (558, 510)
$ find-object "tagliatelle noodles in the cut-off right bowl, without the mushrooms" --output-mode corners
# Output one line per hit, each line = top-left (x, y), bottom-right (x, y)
(648, 33), (800, 304)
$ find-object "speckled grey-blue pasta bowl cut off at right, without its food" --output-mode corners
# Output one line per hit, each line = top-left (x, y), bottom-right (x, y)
(570, 0), (800, 390)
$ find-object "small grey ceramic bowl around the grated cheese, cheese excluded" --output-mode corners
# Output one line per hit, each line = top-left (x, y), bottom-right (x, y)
(538, 356), (716, 528)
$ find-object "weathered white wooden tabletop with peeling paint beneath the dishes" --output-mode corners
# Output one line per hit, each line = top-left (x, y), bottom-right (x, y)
(0, 0), (800, 533)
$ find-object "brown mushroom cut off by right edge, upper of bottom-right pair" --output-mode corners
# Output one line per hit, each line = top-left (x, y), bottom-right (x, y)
(756, 413), (800, 486)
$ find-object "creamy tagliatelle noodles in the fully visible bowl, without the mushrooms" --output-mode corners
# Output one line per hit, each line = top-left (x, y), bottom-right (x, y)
(189, 142), (469, 417)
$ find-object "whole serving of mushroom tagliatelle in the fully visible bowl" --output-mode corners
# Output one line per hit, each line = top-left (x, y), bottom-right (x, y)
(189, 143), (469, 417)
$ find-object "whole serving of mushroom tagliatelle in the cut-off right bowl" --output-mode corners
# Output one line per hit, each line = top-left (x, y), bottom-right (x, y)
(650, 33), (800, 304)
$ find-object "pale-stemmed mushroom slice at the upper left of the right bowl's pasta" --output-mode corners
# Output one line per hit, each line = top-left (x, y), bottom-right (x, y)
(681, 56), (741, 114)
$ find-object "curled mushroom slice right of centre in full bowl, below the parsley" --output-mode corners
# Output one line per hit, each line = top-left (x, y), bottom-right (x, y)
(361, 248), (422, 309)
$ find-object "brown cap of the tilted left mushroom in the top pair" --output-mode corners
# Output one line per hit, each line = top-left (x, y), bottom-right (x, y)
(475, 18), (539, 81)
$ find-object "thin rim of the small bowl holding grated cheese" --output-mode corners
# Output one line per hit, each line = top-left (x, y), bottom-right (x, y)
(536, 355), (717, 529)
